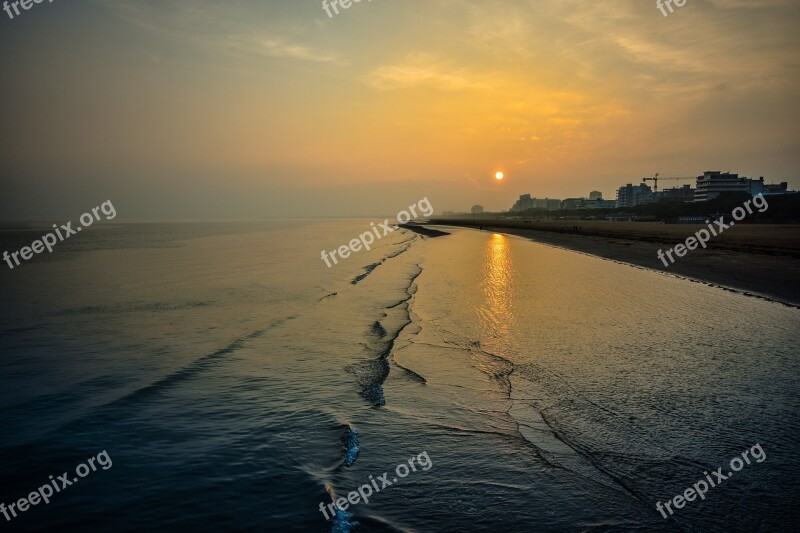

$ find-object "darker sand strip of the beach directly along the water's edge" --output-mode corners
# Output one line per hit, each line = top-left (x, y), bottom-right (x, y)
(424, 220), (800, 308)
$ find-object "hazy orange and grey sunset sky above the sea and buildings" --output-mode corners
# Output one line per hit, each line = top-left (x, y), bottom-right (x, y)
(0, 0), (800, 221)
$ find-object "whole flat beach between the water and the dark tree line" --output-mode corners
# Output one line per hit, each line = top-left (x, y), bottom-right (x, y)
(430, 219), (800, 307)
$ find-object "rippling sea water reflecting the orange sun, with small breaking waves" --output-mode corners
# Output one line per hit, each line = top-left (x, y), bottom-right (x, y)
(0, 219), (800, 532)
